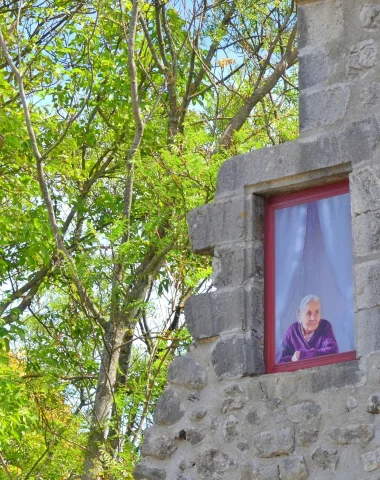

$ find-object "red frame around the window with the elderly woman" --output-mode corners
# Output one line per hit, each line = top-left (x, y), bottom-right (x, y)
(264, 179), (356, 373)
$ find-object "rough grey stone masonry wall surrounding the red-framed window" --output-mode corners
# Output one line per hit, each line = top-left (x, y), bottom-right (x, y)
(134, 0), (380, 480)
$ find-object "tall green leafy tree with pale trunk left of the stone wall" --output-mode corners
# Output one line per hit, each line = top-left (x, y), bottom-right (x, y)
(0, 0), (297, 480)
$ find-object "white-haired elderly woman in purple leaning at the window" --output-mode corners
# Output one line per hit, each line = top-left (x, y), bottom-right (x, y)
(279, 295), (338, 363)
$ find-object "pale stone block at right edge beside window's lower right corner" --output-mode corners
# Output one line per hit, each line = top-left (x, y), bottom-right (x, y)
(356, 308), (380, 357)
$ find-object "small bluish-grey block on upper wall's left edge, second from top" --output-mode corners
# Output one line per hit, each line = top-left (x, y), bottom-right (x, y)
(298, 50), (333, 90)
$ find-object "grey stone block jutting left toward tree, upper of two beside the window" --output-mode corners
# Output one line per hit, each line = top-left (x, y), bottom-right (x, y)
(187, 193), (263, 255)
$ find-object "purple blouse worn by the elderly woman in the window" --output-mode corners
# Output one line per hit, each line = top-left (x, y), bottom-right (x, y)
(278, 320), (338, 363)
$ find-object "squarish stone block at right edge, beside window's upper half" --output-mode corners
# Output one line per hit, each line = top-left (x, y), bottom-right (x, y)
(352, 210), (380, 258)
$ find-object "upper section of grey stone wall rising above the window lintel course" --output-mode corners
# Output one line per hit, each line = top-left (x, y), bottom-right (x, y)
(298, 0), (380, 134)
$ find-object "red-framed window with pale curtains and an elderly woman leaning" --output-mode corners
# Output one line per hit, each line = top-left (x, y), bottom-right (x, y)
(265, 181), (356, 373)
